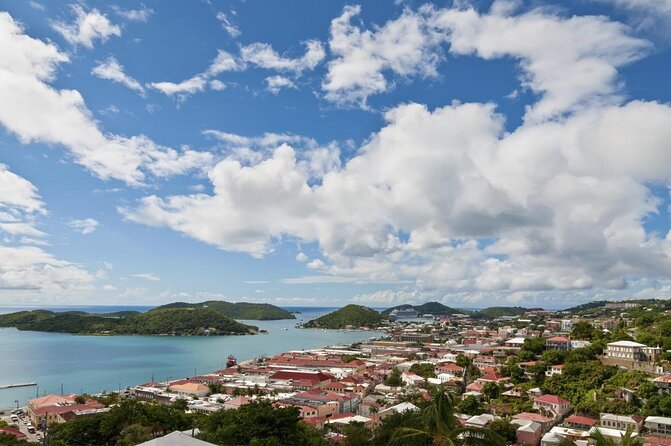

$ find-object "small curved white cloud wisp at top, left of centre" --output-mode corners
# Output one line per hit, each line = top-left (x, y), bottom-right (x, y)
(240, 40), (326, 74)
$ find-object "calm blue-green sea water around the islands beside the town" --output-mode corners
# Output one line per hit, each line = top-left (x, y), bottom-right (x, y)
(0, 306), (379, 408)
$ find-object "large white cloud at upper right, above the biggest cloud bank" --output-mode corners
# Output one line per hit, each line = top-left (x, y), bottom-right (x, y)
(430, 4), (650, 121)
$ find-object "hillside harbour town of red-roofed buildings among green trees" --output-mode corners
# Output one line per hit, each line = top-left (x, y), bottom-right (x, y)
(0, 301), (671, 446)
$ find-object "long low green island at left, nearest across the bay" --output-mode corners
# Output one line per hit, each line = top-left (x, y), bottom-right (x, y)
(0, 308), (258, 336)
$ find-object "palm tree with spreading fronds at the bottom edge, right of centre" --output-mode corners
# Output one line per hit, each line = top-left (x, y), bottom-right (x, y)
(392, 389), (505, 446)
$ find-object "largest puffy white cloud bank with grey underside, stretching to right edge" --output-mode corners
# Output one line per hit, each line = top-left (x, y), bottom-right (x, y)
(122, 97), (671, 292)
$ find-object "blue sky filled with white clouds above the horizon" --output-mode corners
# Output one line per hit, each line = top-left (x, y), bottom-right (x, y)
(0, 0), (671, 308)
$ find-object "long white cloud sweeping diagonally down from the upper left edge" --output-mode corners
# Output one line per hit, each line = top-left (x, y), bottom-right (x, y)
(0, 13), (212, 185)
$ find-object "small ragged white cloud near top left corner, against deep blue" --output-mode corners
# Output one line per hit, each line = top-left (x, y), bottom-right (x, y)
(51, 4), (121, 48)
